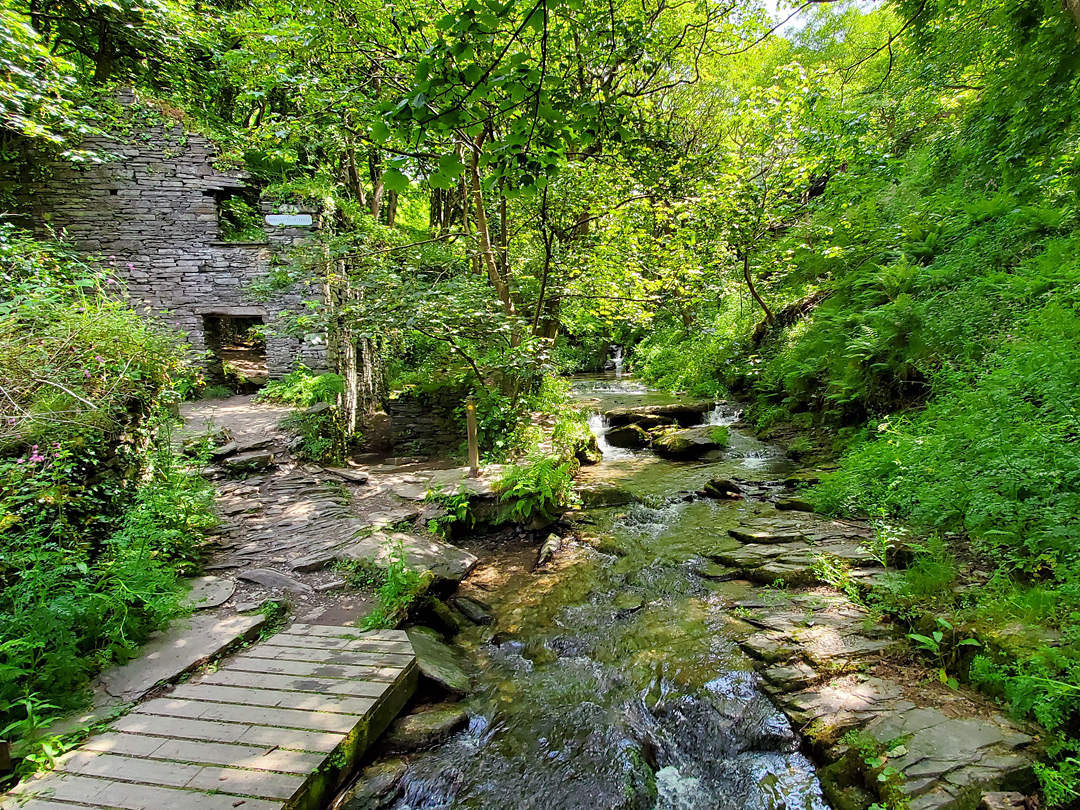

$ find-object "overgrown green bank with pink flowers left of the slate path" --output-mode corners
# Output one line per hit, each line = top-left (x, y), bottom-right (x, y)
(0, 226), (214, 738)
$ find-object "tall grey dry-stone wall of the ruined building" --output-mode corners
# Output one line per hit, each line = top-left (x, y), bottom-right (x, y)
(24, 96), (326, 377)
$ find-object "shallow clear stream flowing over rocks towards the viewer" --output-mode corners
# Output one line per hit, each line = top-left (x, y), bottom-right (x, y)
(391, 378), (826, 810)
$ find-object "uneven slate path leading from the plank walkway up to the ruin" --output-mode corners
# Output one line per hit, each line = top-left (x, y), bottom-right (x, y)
(176, 396), (495, 624)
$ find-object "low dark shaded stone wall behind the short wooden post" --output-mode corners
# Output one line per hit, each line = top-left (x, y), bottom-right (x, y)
(387, 391), (468, 456)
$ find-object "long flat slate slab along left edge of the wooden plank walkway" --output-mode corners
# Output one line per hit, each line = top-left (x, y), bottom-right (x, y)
(102, 615), (266, 701)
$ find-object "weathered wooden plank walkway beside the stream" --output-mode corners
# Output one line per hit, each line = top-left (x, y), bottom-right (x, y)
(0, 624), (418, 810)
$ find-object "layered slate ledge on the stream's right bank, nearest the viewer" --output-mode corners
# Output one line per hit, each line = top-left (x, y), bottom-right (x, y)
(735, 589), (1037, 810)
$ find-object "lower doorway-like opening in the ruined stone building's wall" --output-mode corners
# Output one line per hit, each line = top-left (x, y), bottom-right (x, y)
(203, 315), (269, 394)
